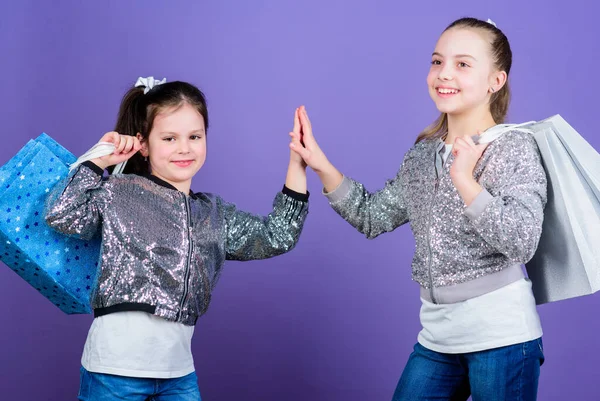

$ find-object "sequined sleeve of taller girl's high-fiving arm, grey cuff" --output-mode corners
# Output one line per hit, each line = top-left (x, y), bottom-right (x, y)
(325, 163), (408, 239)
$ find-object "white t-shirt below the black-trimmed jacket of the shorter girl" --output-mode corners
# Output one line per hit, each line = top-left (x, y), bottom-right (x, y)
(81, 311), (194, 379)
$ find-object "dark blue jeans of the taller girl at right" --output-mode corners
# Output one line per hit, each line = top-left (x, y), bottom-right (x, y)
(393, 338), (544, 401)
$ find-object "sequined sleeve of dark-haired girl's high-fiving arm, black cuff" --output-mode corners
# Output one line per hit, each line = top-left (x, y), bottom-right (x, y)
(221, 188), (308, 260)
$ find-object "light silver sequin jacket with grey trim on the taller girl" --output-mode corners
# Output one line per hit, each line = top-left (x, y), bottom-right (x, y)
(325, 131), (547, 303)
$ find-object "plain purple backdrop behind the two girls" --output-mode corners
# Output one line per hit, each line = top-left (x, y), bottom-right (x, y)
(0, 0), (600, 401)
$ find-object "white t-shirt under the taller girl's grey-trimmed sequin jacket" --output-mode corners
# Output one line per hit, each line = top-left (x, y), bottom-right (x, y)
(417, 145), (543, 354)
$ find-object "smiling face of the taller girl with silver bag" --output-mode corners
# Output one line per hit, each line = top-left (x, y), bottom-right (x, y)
(427, 27), (506, 115)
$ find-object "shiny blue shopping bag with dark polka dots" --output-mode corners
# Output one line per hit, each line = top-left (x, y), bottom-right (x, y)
(0, 133), (100, 314)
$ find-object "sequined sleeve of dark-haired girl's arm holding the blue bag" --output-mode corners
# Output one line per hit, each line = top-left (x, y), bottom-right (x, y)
(44, 163), (102, 239)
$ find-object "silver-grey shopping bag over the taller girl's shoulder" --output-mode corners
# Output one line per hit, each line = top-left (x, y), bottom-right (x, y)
(480, 115), (600, 305)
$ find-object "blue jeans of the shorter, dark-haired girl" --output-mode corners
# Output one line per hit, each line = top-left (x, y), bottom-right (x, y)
(77, 367), (201, 401)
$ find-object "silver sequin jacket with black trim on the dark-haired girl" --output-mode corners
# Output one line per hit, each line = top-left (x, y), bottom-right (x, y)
(45, 162), (308, 325)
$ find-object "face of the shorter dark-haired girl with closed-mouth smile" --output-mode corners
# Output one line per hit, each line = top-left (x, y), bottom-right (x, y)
(141, 103), (206, 194)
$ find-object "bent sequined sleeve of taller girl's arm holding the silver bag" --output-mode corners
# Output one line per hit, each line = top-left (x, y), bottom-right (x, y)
(465, 132), (547, 263)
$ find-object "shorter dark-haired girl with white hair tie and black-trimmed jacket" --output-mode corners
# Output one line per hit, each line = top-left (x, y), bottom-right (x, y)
(45, 78), (308, 401)
